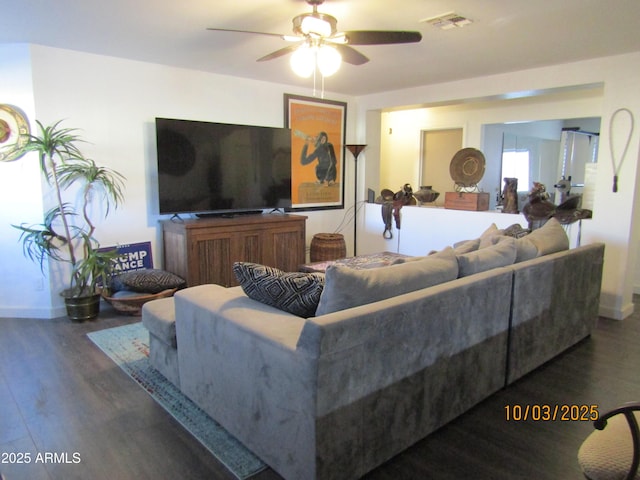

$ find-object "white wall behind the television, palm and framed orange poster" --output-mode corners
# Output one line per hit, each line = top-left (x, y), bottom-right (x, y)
(0, 46), (356, 318)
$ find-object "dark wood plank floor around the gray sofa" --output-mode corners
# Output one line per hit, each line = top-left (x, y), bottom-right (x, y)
(0, 298), (640, 480)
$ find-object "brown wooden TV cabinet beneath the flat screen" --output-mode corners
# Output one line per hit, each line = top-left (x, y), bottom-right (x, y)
(162, 214), (307, 287)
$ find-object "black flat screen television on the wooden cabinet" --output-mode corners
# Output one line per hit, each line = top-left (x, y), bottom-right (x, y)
(156, 118), (291, 215)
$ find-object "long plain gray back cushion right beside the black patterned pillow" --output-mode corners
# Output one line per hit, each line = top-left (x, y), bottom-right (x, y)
(316, 248), (458, 315)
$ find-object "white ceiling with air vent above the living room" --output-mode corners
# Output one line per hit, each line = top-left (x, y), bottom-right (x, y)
(0, 0), (640, 95)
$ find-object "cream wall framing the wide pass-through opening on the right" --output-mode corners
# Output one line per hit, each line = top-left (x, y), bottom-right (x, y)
(358, 53), (640, 319)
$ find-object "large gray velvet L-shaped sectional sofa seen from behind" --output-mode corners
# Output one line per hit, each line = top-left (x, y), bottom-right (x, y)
(142, 220), (604, 480)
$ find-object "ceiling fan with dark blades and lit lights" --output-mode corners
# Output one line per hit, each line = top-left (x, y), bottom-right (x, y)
(207, 0), (422, 65)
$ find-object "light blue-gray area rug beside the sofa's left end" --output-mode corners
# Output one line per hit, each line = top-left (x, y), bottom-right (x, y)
(87, 322), (266, 480)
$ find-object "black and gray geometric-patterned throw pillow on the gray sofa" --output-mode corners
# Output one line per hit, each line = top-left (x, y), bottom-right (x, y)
(233, 262), (324, 318)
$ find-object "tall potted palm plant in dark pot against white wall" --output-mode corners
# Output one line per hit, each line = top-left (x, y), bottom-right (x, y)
(13, 121), (124, 321)
